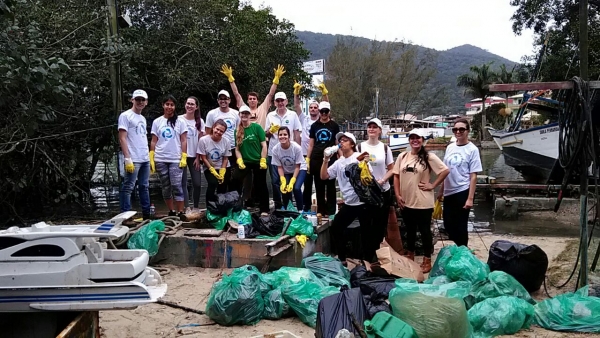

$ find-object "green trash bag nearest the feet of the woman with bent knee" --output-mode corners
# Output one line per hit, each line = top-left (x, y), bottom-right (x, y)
(300, 252), (350, 288)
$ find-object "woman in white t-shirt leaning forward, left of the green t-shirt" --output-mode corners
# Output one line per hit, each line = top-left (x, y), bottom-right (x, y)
(196, 119), (231, 201)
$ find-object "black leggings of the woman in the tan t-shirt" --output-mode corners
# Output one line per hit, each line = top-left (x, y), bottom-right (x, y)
(402, 207), (433, 257)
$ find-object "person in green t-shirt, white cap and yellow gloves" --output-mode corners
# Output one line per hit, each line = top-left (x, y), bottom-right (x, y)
(233, 106), (269, 213)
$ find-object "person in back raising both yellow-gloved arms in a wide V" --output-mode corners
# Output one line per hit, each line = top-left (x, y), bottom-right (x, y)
(221, 65), (285, 126)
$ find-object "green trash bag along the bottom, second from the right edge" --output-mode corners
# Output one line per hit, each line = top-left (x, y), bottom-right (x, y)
(467, 296), (534, 338)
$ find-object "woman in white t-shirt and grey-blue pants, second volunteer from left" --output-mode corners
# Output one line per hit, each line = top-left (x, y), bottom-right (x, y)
(150, 95), (187, 216)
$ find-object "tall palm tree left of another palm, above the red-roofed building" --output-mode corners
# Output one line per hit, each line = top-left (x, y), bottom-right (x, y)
(457, 62), (498, 141)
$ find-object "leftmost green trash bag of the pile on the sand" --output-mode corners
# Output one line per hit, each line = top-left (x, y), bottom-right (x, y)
(205, 270), (265, 326)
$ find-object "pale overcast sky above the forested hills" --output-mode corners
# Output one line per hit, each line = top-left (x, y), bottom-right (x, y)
(251, 0), (533, 61)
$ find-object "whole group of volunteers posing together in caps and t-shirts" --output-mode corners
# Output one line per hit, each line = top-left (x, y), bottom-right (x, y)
(118, 65), (482, 272)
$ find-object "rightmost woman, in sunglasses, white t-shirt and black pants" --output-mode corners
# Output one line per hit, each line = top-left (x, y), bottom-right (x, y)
(438, 119), (483, 246)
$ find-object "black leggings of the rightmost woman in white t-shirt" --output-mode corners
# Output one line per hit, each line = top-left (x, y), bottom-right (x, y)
(444, 189), (470, 246)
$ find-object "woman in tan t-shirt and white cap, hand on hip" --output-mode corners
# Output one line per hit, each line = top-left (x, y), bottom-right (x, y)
(394, 129), (450, 273)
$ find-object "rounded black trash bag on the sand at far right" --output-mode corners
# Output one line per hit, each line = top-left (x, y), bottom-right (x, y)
(488, 240), (548, 292)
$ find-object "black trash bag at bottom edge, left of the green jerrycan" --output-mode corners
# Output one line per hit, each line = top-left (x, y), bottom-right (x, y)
(315, 285), (371, 338)
